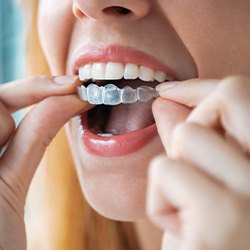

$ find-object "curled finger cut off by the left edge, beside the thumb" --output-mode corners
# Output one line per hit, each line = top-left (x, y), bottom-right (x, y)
(0, 102), (15, 147)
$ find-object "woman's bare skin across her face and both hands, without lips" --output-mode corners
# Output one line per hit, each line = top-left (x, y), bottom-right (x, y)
(0, 0), (250, 250)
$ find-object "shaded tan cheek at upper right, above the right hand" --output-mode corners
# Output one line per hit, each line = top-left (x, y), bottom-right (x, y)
(158, 0), (250, 78)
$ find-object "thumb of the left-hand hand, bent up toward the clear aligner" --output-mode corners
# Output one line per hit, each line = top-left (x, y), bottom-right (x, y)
(0, 95), (91, 197)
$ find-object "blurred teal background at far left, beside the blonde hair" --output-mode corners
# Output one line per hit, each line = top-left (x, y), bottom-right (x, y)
(0, 0), (26, 123)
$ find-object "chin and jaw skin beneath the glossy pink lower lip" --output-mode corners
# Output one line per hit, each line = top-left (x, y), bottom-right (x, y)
(67, 117), (164, 221)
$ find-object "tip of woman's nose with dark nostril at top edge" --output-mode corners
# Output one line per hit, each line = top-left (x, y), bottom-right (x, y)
(73, 0), (150, 21)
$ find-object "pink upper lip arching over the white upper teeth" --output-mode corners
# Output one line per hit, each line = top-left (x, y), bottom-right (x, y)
(71, 44), (178, 79)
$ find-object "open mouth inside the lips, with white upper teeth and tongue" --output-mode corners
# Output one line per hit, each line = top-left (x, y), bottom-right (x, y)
(79, 62), (173, 137)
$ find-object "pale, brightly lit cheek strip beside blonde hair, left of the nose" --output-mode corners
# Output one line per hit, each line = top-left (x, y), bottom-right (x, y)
(38, 0), (74, 75)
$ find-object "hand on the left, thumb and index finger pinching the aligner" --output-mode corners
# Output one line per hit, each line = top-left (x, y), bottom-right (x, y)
(0, 76), (90, 250)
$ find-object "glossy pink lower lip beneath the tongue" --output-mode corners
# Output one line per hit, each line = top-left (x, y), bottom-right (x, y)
(81, 113), (157, 157)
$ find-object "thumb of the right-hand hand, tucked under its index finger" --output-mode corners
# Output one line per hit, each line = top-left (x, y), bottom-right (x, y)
(152, 98), (190, 150)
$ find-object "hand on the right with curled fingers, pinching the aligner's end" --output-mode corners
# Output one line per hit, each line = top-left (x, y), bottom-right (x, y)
(147, 77), (250, 250)
